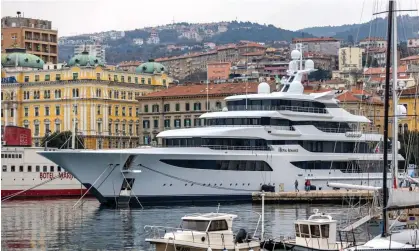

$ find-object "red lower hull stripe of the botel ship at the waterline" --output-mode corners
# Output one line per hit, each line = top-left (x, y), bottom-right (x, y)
(1, 188), (87, 198)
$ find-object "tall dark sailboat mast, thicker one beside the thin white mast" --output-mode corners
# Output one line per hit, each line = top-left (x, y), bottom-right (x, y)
(381, 0), (394, 237)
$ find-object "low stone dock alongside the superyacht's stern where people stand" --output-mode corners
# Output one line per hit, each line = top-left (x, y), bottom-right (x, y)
(252, 190), (374, 204)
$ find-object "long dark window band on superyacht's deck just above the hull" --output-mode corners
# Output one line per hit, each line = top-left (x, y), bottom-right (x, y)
(163, 137), (377, 153)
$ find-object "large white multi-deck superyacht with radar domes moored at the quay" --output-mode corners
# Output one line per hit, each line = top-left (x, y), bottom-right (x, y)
(40, 50), (396, 205)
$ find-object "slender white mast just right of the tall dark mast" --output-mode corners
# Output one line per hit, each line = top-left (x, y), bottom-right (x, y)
(387, 0), (399, 188)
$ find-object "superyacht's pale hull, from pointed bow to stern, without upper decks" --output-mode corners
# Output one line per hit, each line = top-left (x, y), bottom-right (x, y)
(41, 147), (394, 203)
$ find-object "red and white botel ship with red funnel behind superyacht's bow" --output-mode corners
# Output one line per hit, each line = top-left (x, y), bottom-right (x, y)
(1, 126), (86, 199)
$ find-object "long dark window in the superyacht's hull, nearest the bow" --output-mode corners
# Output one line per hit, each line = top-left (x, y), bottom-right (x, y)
(160, 159), (272, 171)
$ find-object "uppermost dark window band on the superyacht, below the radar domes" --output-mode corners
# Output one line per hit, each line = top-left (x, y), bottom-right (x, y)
(227, 99), (338, 111)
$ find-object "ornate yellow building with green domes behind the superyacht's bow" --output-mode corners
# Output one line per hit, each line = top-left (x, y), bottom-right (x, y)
(1, 49), (173, 149)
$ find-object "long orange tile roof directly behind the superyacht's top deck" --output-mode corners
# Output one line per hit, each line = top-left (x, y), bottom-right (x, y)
(139, 82), (275, 99)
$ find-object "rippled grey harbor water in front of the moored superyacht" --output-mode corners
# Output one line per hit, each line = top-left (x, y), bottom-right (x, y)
(1, 199), (377, 250)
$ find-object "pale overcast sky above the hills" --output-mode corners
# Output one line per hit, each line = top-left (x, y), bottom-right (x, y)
(1, 0), (419, 36)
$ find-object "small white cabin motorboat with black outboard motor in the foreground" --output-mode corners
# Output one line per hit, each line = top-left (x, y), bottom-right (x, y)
(144, 213), (260, 251)
